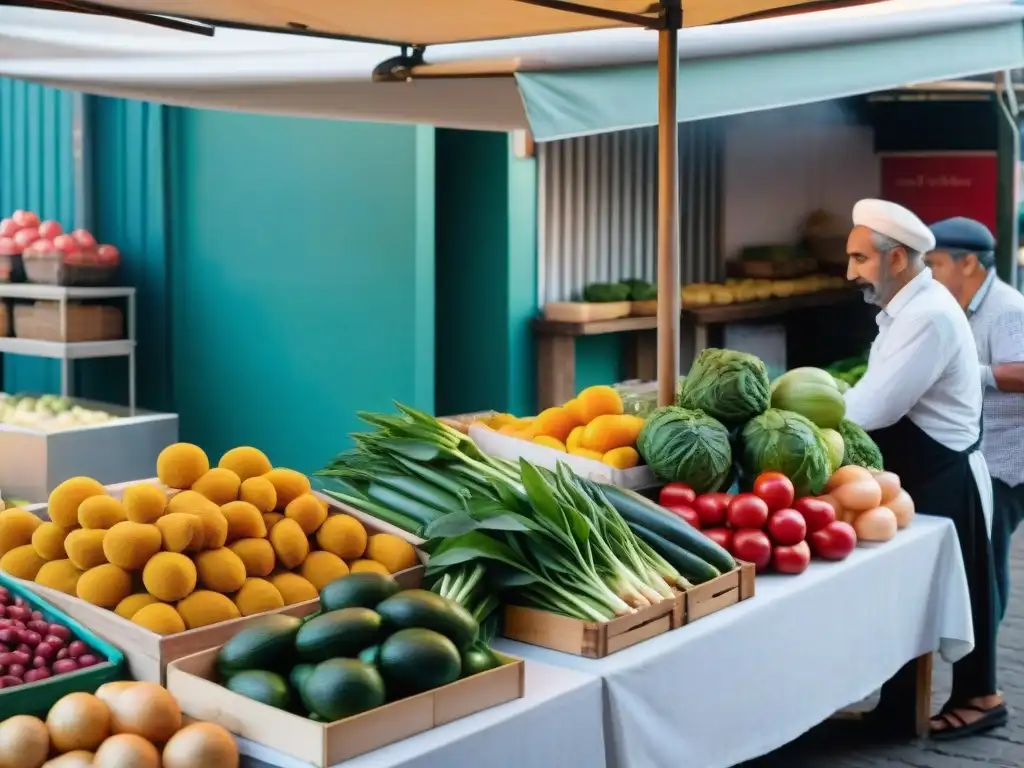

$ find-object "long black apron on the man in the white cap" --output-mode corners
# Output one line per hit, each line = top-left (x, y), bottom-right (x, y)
(870, 417), (996, 713)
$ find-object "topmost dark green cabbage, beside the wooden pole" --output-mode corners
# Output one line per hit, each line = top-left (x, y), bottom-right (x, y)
(679, 349), (771, 425)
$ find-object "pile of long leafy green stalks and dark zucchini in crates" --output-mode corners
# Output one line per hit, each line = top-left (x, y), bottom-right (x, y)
(317, 406), (735, 622)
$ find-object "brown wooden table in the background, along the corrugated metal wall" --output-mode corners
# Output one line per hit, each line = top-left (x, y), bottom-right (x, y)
(534, 289), (860, 411)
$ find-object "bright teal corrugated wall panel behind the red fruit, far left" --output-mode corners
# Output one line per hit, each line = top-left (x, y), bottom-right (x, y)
(0, 79), (75, 391)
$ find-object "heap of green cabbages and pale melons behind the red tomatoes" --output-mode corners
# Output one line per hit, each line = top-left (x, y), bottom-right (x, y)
(637, 349), (883, 496)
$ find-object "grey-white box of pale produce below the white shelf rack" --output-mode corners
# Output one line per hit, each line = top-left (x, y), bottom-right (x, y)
(0, 400), (178, 502)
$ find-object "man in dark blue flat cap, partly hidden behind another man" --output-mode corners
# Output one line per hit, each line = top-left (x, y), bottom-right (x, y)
(925, 217), (1024, 625)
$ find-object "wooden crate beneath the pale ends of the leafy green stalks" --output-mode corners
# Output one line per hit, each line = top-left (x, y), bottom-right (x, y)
(502, 600), (677, 658)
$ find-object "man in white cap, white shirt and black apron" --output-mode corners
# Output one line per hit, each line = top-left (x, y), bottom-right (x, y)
(845, 200), (1008, 739)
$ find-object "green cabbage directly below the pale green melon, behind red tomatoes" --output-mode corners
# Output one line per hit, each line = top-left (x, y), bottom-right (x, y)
(740, 409), (831, 497)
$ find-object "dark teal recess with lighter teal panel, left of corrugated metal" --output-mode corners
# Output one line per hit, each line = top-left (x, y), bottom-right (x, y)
(436, 130), (537, 421)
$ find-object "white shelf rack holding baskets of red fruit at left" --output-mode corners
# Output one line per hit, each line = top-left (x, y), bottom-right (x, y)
(0, 283), (135, 412)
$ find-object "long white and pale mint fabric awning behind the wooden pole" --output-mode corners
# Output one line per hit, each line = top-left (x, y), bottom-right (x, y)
(0, 0), (1024, 140)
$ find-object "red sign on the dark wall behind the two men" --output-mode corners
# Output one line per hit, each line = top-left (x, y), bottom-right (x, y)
(882, 153), (996, 233)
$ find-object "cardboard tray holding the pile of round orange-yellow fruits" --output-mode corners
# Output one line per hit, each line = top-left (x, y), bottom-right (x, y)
(19, 478), (424, 684)
